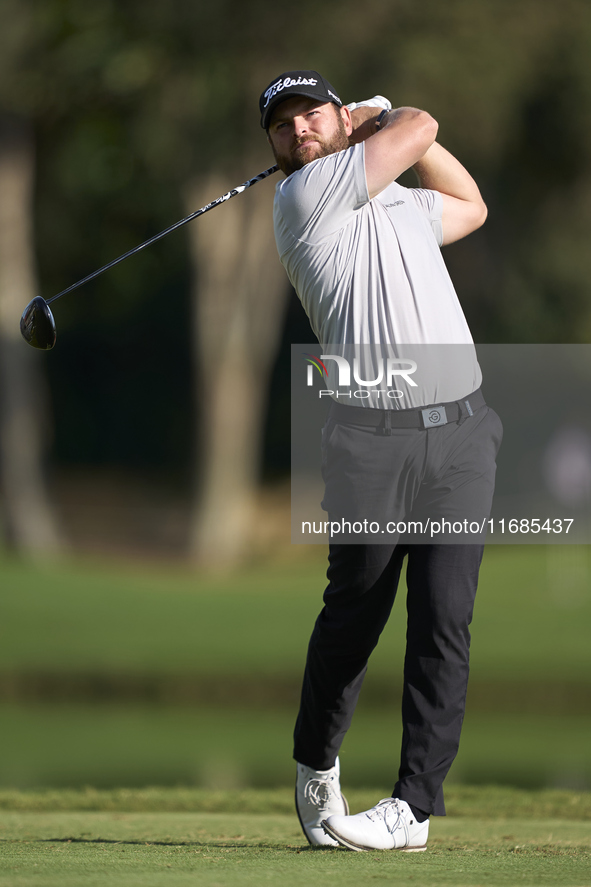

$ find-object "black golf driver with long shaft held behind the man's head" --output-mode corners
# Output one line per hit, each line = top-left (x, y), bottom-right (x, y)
(20, 166), (279, 351)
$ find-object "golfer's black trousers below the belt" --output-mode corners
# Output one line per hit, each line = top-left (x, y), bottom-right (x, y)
(294, 406), (502, 816)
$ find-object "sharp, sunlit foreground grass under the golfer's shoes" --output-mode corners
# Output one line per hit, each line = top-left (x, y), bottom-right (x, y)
(0, 789), (591, 887)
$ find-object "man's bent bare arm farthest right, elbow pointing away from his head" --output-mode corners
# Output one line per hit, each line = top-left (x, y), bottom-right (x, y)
(413, 142), (487, 246)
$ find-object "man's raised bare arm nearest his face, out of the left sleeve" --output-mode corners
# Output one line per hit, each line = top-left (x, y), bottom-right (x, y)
(349, 105), (438, 198)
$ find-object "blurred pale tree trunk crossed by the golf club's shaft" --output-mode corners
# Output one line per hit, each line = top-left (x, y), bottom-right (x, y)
(185, 165), (287, 566)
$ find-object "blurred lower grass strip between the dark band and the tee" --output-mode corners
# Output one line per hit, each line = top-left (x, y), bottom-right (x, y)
(0, 703), (591, 794)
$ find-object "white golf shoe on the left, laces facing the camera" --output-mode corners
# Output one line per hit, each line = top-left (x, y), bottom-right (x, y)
(296, 758), (349, 847)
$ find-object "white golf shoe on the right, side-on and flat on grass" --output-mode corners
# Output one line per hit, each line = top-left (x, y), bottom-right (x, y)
(322, 798), (429, 852)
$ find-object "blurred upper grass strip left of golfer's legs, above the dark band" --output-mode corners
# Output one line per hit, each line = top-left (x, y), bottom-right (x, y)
(0, 560), (322, 674)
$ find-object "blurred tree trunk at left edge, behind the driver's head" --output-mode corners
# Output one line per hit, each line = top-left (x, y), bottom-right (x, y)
(0, 115), (61, 555)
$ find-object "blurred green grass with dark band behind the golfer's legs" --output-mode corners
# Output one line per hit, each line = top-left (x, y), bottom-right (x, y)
(0, 546), (591, 792)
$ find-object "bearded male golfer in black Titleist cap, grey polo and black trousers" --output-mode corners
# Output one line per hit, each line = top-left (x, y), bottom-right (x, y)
(260, 71), (502, 851)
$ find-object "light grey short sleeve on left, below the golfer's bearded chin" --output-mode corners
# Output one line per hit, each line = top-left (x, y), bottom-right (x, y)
(275, 143), (369, 243)
